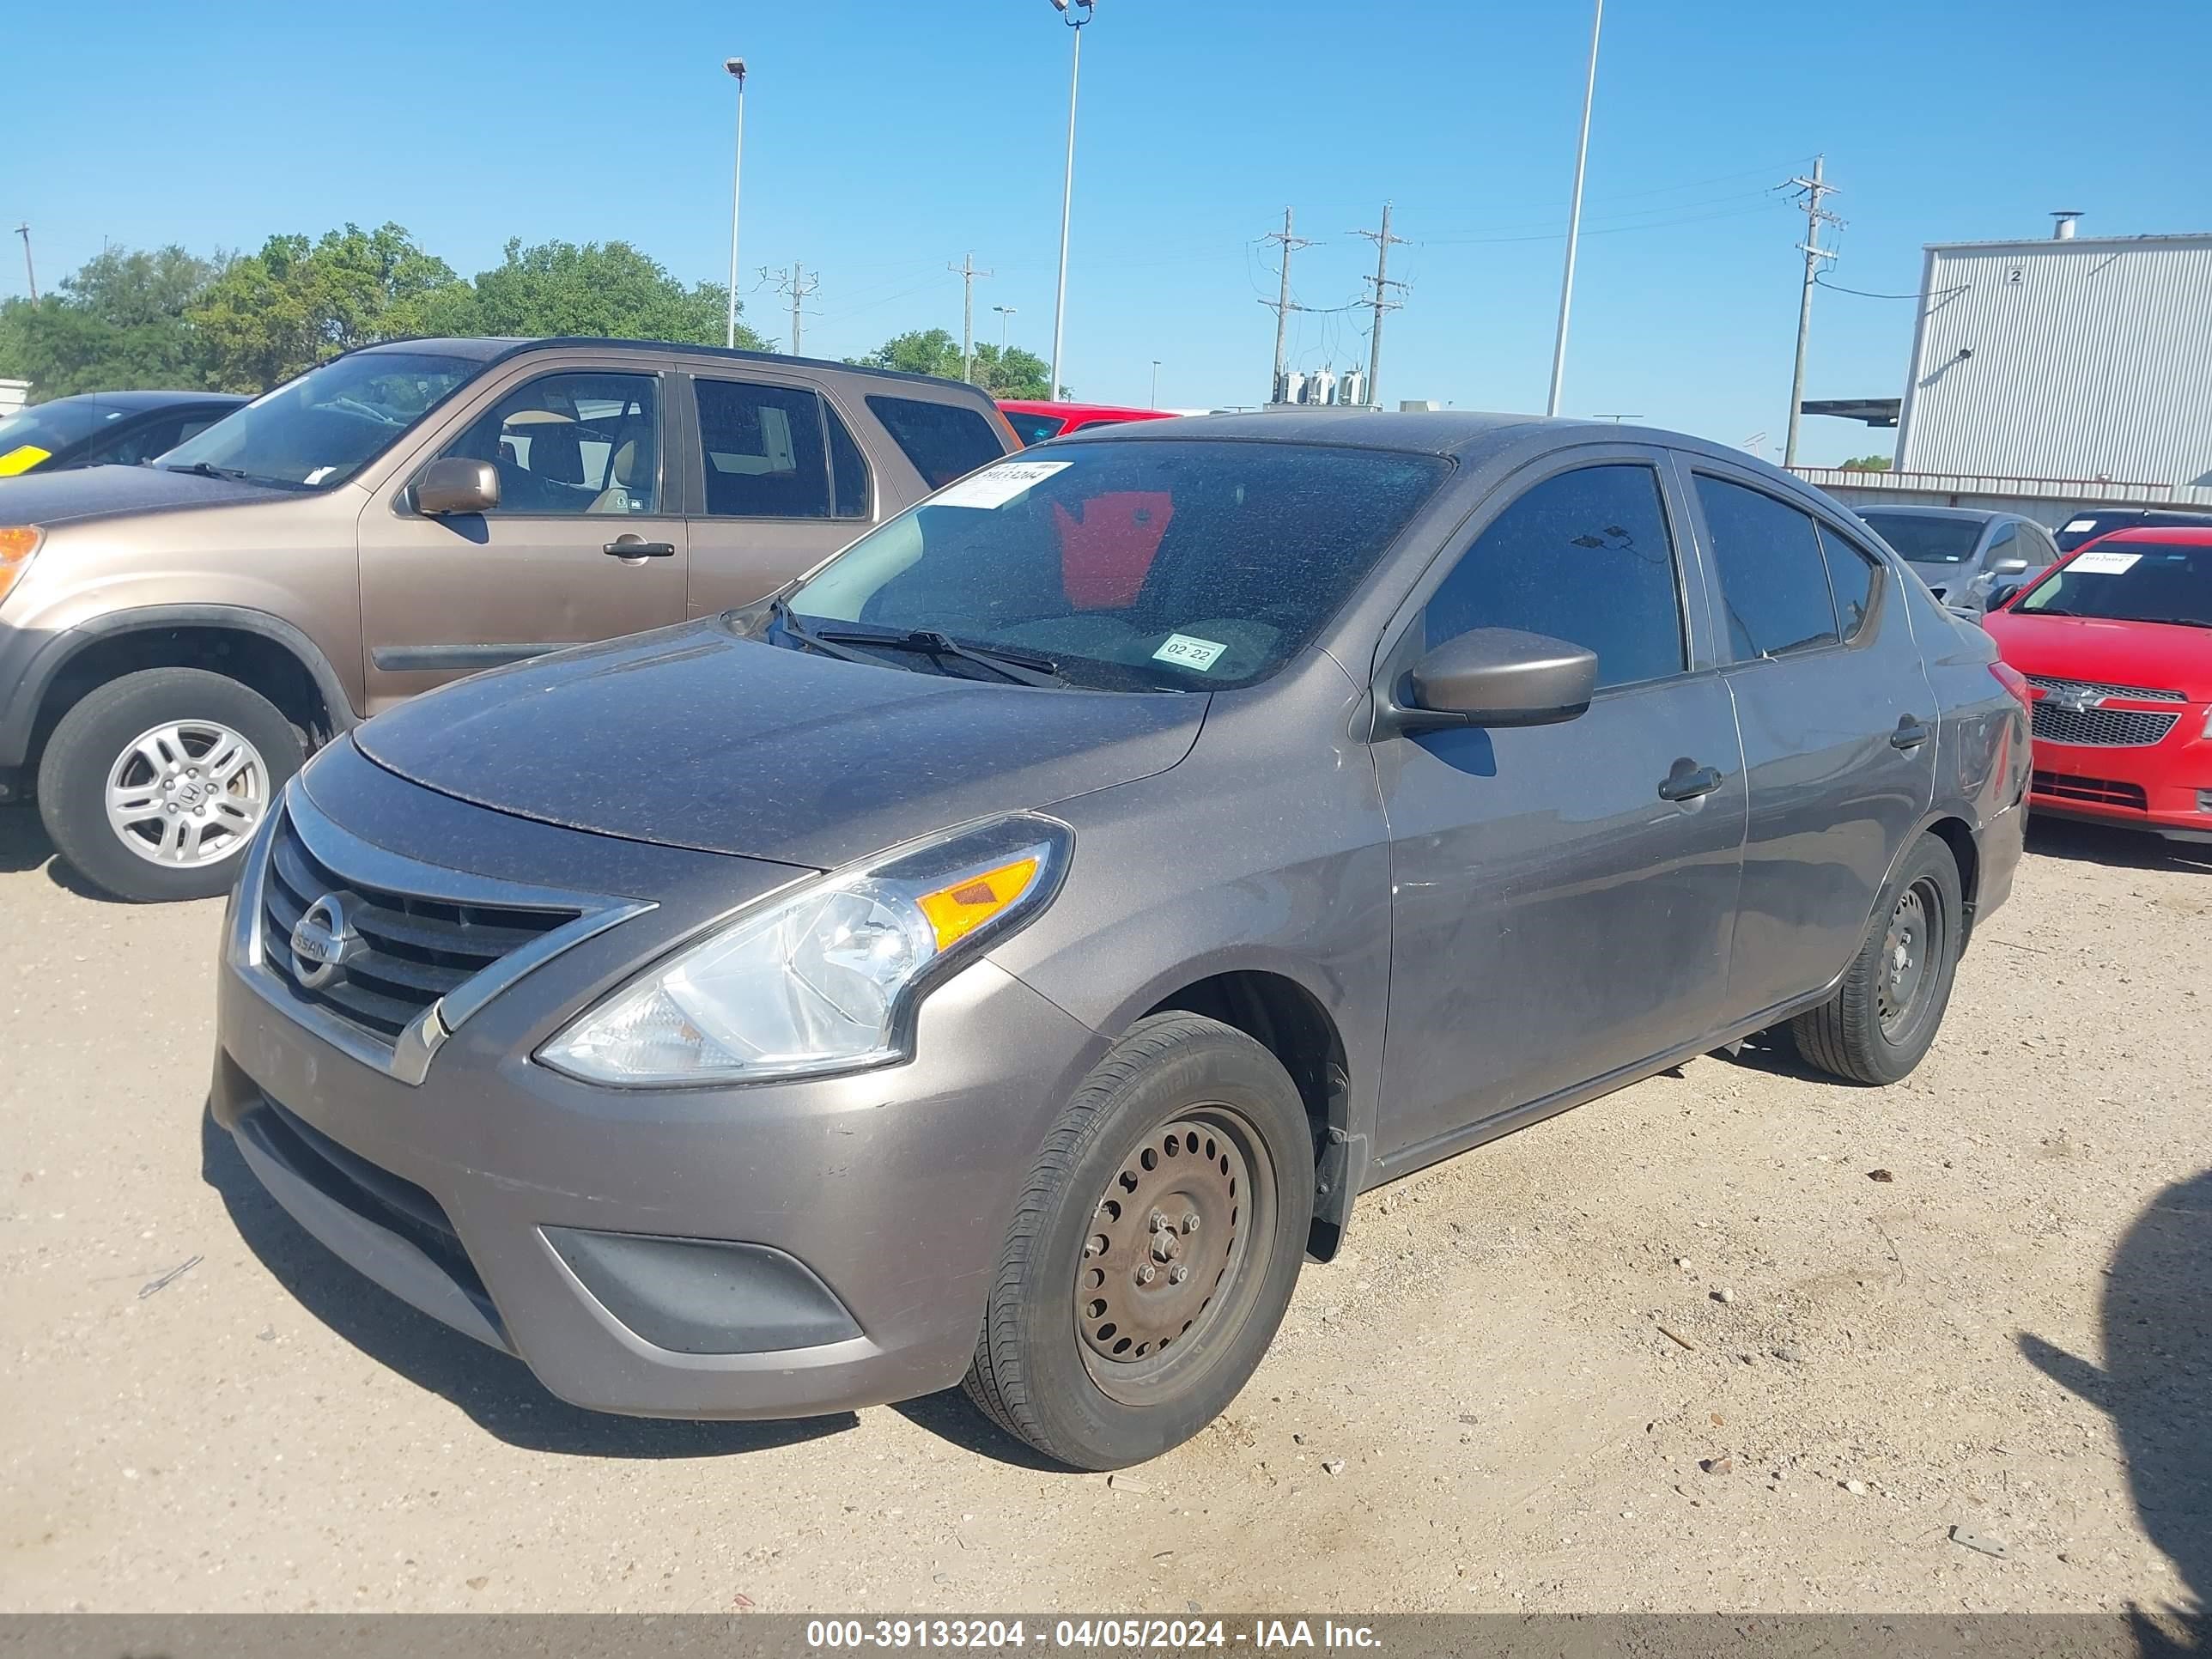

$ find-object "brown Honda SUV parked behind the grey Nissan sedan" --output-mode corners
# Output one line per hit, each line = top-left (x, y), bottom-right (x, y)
(0, 341), (1018, 900)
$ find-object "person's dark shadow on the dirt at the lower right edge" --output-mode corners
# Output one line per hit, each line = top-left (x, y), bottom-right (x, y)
(2020, 1170), (2212, 1655)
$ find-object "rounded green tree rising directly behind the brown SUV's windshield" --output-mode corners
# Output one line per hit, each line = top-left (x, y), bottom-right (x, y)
(191, 223), (465, 392)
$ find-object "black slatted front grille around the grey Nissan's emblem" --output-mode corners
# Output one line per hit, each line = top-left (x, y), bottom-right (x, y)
(261, 814), (581, 1044)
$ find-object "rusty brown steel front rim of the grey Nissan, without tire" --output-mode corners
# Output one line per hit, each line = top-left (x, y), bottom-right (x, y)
(1075, 1106), (1276, 1405)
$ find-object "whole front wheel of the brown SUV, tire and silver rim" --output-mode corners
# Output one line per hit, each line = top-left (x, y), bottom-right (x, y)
(38, 668), (307, 905)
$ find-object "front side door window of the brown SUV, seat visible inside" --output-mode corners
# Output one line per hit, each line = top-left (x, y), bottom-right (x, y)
(445, 372), (661, 518)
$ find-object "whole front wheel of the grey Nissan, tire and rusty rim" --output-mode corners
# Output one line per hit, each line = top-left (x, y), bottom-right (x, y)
(967, 1013), (1314, 1468)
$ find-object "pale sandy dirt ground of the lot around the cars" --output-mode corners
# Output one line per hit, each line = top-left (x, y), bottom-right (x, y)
(0, 810), (2212, 1613)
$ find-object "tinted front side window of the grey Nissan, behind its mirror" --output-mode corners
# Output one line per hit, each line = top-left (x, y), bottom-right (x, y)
(1427, 462), (1683, 686)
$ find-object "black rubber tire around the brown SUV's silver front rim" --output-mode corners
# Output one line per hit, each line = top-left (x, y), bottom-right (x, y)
(38, 668), (307, 905)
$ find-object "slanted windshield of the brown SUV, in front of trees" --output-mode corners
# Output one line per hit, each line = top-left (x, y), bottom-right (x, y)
(157, 352), (483, 489)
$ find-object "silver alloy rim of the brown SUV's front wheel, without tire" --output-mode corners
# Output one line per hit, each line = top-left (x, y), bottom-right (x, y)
(106, 721), (270, 869)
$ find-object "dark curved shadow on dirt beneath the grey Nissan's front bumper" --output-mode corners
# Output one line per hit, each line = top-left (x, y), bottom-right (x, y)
(199, 1113), (858, 1458)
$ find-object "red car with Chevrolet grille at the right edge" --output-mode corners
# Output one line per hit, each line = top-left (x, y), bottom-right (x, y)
(1982, 526), (2212, 841)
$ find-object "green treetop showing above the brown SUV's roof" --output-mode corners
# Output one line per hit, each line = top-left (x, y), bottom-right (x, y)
(441, 239), (763, 352)
